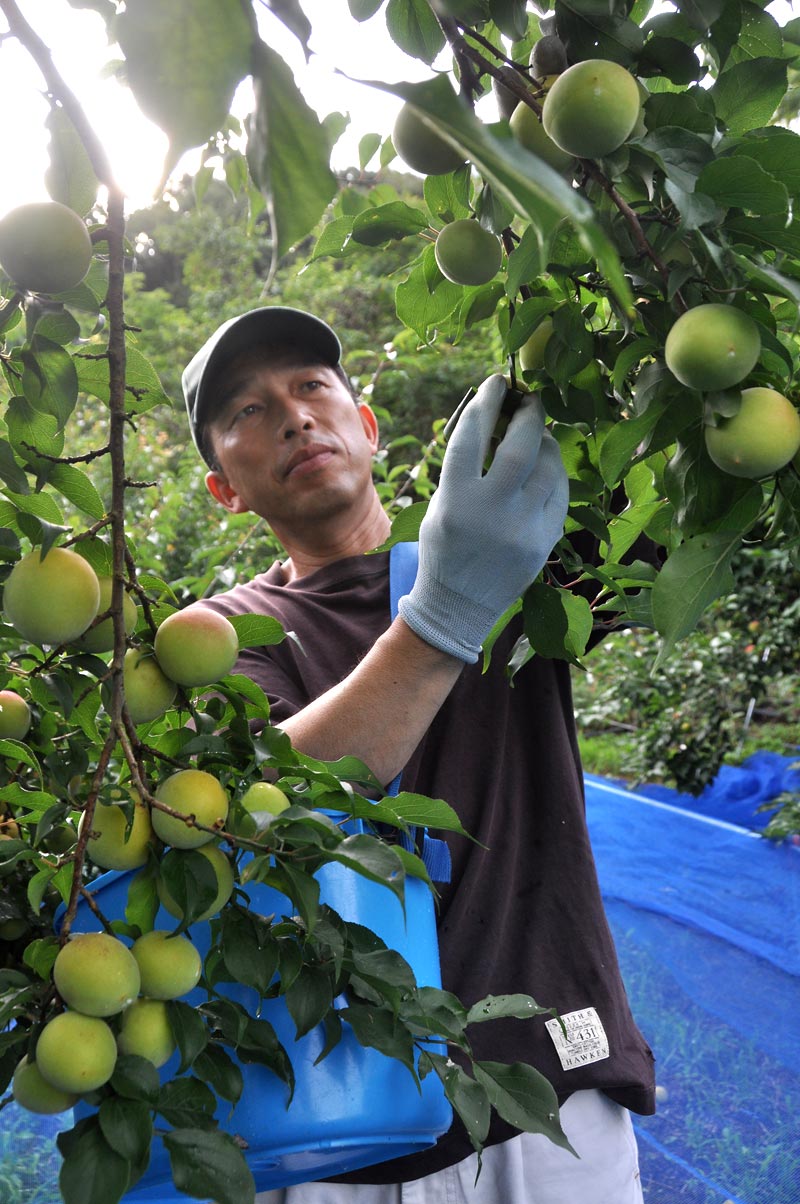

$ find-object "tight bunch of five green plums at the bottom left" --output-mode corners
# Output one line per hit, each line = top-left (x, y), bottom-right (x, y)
(12, 929), (202, 1112)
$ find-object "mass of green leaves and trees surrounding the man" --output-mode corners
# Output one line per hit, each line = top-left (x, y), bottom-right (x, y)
(0, 0), (800, 1204)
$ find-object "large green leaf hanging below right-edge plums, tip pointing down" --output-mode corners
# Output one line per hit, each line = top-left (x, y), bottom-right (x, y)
(653, 531), (742, 667)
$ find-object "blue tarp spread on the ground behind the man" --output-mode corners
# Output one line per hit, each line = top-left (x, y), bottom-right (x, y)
(587, 767), (800, 1204)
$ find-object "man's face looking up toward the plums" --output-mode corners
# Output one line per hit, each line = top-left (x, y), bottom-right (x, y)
(206, 356), (377, 537)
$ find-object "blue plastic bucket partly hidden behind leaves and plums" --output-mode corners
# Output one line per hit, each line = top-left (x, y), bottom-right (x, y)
(73, 863), (452, 1204)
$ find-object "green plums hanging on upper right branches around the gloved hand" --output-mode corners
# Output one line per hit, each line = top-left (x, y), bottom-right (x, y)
(393, 30), (800, 480)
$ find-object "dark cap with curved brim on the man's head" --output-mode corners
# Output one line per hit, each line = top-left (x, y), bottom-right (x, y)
(181, 305), (342, 455)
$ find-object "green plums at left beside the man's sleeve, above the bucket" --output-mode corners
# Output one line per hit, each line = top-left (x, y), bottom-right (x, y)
(0, 547), (239, 739)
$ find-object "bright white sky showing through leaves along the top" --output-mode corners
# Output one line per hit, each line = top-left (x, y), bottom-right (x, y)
(0, 0), (794, 216)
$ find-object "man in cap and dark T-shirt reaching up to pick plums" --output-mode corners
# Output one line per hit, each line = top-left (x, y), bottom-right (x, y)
(183, 307), (654, 1204)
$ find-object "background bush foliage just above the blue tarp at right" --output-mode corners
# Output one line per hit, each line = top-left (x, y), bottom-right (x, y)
(576, 548), (800, 795)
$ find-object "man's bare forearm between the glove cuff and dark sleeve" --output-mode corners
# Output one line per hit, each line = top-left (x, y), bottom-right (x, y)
(280, 619), (464, 785)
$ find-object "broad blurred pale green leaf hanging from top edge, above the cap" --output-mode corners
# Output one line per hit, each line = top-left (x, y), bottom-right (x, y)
(114, 0), (254, 177)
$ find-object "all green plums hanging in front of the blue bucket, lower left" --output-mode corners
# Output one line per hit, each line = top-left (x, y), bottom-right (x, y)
(13, 769), (289, 1112)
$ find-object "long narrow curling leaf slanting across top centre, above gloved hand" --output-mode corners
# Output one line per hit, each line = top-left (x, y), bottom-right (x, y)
(364, 76), (633, 313)
